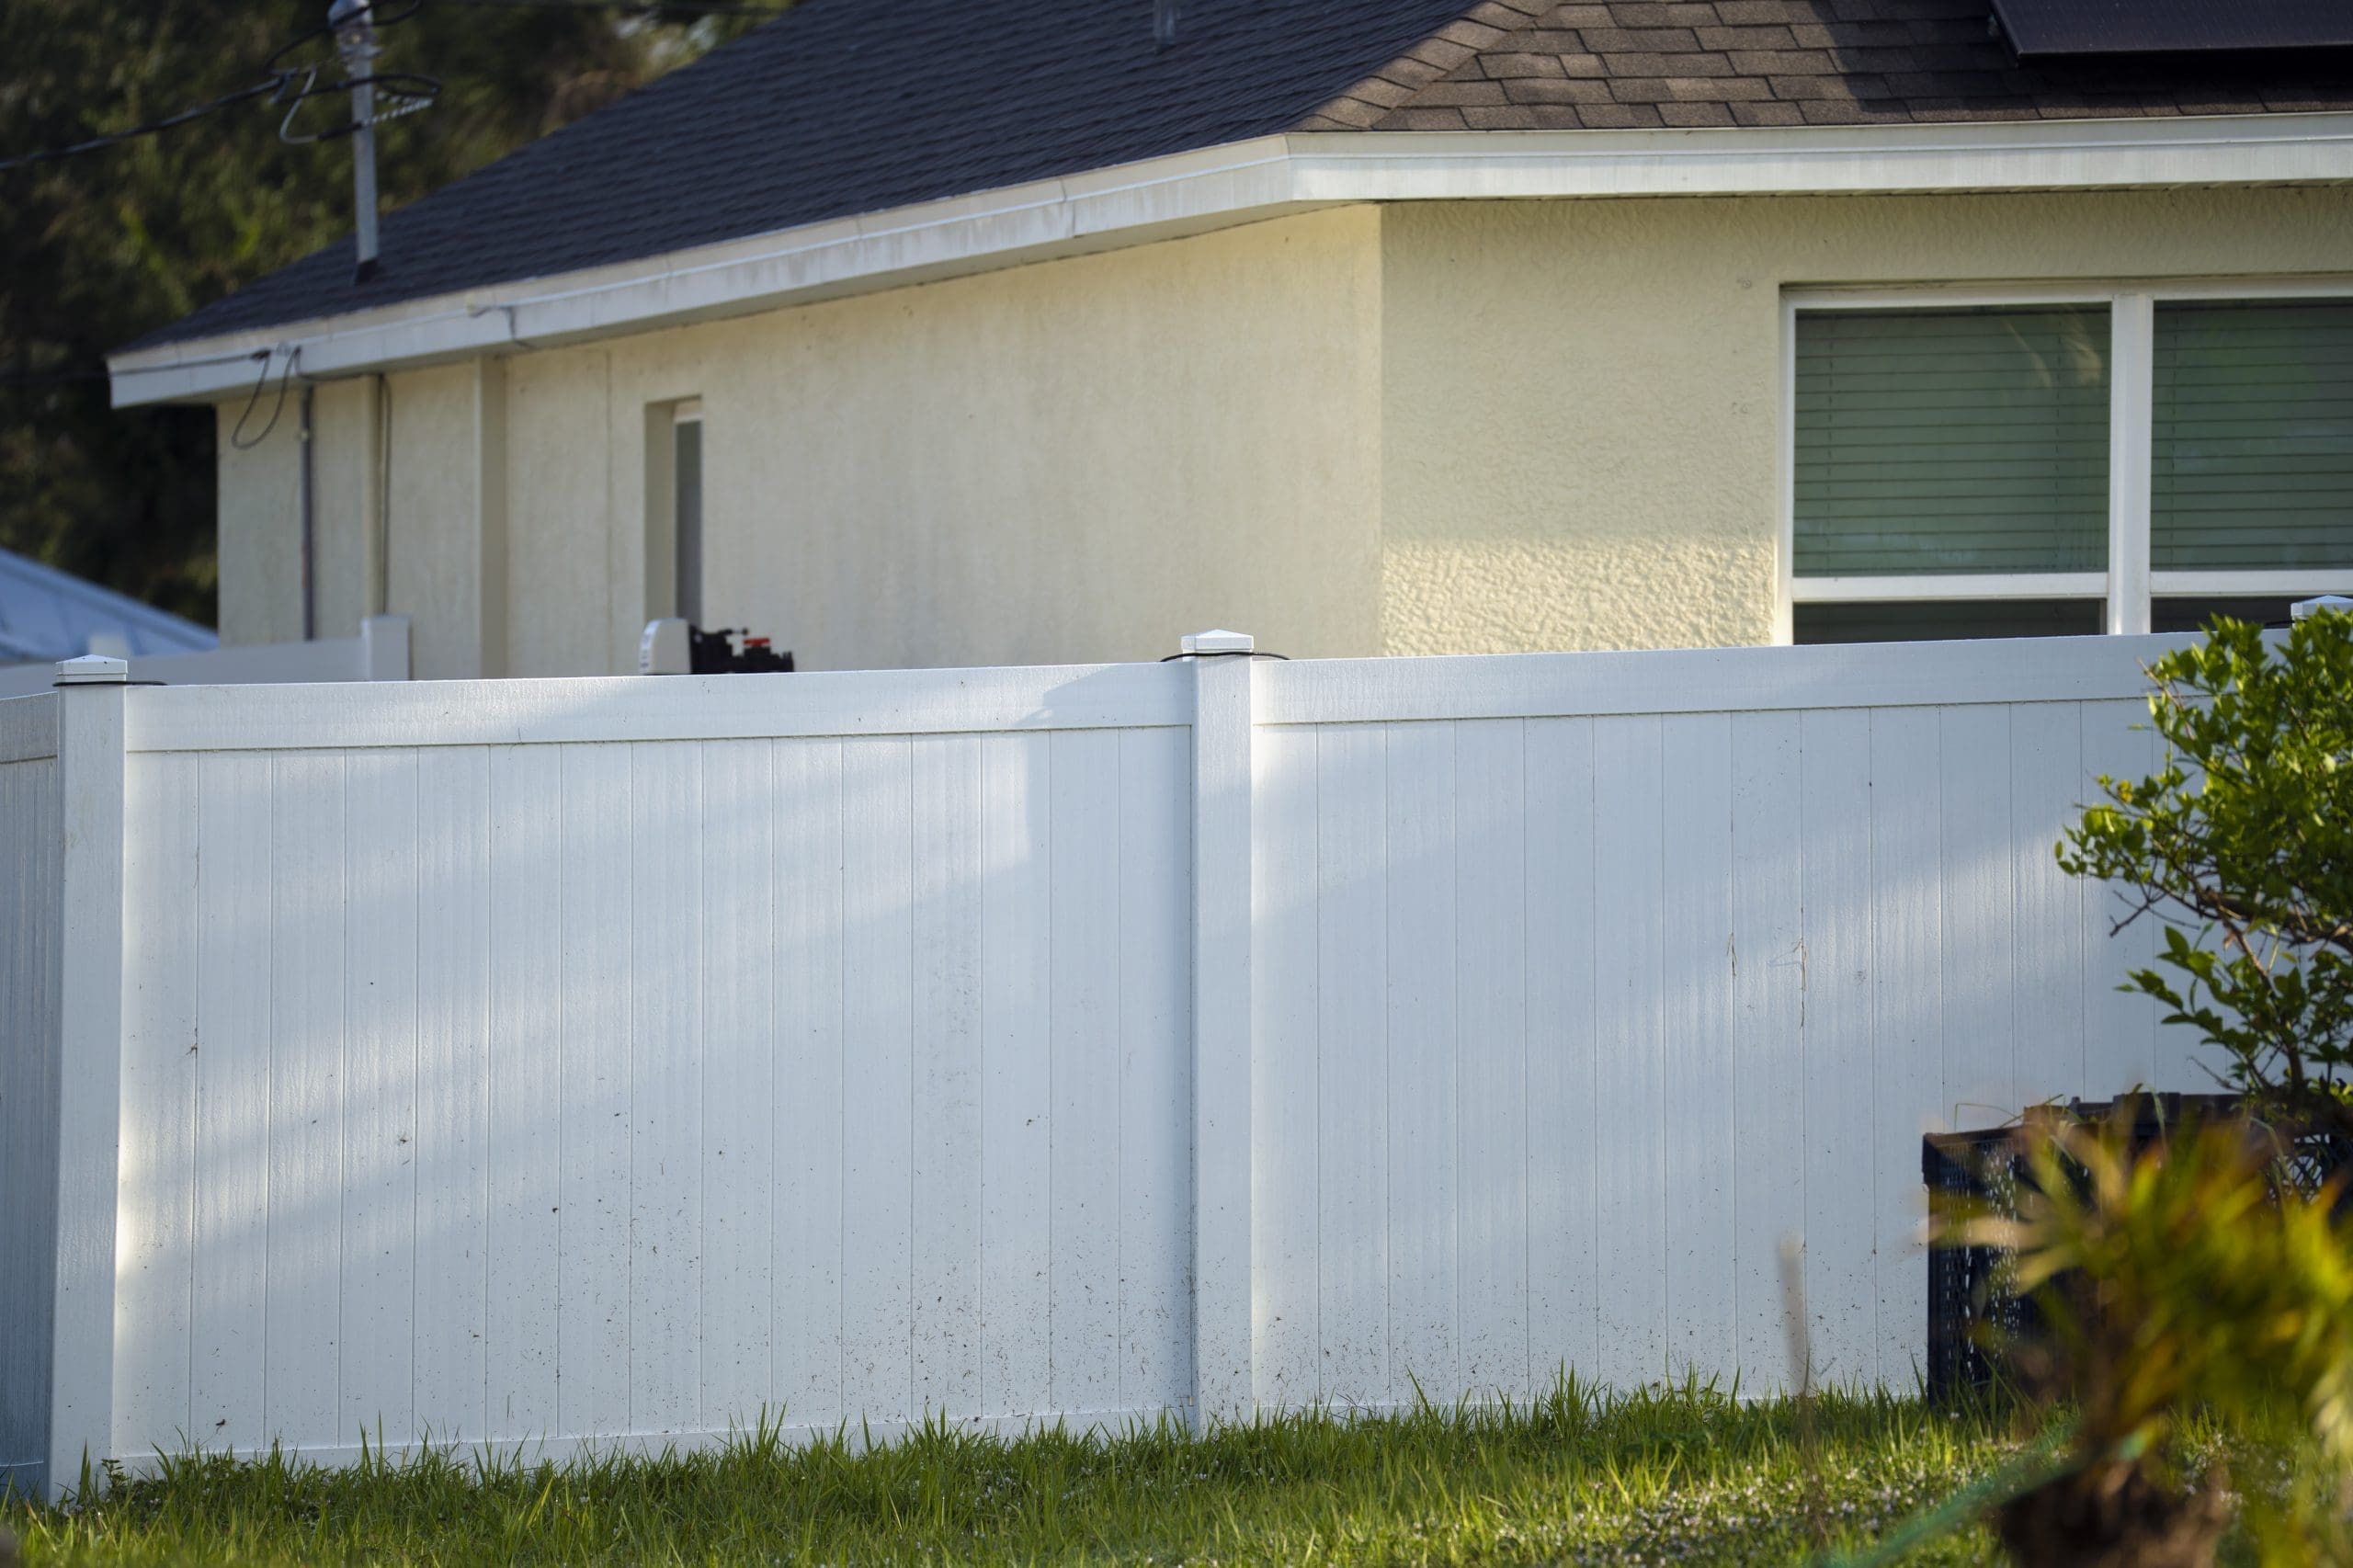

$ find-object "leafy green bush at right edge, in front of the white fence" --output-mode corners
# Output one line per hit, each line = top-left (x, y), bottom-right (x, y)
(2059, 615), (2353, 1135)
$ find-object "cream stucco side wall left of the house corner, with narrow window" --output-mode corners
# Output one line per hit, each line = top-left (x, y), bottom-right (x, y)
(241, 210), (1379, 676)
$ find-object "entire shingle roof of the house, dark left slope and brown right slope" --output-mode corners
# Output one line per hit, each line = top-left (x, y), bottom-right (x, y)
(134, 0), (2353, 348)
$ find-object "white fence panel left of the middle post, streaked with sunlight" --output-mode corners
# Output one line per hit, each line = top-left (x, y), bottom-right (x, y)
(101, 668), (1193, 1458)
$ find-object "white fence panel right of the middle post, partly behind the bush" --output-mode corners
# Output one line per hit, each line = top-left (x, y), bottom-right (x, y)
(1254, 641), (2205, 1405)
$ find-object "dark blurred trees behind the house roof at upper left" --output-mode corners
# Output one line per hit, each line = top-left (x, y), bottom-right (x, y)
(0, 0), (753, 621)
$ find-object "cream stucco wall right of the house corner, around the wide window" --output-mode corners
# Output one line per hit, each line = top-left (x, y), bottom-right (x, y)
(1381, 188), (2353, 654)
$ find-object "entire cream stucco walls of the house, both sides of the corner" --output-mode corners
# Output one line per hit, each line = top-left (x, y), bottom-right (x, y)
(222, 188), (2353, 676)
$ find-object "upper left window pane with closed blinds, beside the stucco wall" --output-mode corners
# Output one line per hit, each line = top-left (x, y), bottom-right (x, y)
(1795, 306), (2109, 577)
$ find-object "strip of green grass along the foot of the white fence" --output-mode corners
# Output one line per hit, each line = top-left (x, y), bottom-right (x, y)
(0, 1387), (2080, 1568)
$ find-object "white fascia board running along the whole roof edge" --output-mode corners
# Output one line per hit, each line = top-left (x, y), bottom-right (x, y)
(108, 113), (2353, 407)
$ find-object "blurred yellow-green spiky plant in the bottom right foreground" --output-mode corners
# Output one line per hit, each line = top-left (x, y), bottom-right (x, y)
(1941, 1107), (2353, 1568)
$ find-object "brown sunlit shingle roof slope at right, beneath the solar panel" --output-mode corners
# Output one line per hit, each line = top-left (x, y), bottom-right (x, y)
(1302, 0), (2353, 130)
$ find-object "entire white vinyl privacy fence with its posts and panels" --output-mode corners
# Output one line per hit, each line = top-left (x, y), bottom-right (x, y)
(0, 638), (2202, 1488)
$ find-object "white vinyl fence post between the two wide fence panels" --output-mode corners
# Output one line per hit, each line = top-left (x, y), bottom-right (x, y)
(1184, 631), (1256, 1429)
